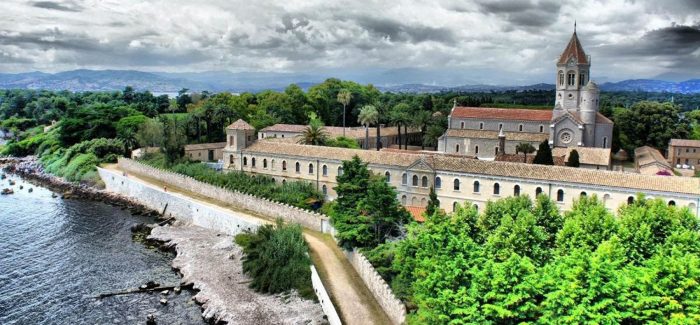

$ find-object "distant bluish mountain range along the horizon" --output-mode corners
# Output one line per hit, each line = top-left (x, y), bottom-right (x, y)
(0, 69), (700, 93)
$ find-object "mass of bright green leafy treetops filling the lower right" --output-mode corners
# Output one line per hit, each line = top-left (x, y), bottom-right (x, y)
(368, 195), (700, 324)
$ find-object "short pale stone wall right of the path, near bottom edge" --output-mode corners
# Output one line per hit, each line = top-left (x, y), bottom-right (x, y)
(345, 249), (406, 325)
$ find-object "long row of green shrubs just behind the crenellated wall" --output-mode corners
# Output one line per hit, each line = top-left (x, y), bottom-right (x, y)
(140, 154), (323, 209)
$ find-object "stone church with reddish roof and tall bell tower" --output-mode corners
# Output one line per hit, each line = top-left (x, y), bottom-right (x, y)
(438, 32), (613, 159)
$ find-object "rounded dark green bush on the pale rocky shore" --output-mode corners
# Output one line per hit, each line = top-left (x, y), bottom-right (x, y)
(235, 219), (316, 299)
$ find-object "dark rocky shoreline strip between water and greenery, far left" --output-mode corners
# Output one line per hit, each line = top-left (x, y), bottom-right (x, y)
(0, 157), (160, 217)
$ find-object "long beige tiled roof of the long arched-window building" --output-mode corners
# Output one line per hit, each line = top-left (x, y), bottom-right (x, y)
(244, 141), (700, 195)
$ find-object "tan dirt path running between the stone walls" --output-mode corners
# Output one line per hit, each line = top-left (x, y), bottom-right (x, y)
(104, 164), (391, 325)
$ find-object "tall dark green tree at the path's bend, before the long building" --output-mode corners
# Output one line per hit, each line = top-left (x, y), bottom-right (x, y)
(330, 156), (410, 248)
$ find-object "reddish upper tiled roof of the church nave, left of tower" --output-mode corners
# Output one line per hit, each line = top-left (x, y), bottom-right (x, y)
(451, 106), (552, 122)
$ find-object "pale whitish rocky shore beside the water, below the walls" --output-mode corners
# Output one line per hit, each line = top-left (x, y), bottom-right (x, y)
(149, 221), (327, 324)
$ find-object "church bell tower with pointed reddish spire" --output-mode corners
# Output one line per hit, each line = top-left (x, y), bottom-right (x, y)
(555, 23), (591, 112)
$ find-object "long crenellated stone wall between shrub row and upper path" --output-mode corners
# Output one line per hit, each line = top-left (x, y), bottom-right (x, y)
(119, 158), (334, 234)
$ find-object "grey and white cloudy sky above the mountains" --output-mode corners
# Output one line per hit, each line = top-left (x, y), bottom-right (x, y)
(0, 0), (700, 84)
